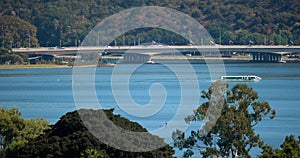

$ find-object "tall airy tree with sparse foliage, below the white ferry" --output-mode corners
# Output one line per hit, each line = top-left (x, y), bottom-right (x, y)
(173, 81), (275, 157)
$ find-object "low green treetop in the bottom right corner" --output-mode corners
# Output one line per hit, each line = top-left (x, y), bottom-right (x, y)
(259, 135), (300, 158)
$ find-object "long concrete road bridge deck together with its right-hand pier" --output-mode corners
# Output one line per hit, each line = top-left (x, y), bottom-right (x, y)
(13, 45), (300, 62)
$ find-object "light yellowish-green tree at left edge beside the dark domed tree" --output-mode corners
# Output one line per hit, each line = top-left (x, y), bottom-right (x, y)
(0, 108), (49, 157)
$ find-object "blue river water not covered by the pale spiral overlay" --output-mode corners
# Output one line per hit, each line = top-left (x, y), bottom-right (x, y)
(0, 63), (300, 155)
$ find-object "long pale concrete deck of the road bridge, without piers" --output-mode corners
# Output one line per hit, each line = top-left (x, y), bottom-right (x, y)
(12, 45), (300, 55)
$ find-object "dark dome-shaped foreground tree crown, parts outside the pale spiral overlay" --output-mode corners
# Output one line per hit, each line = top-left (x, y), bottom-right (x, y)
(20, 110), (174, 158)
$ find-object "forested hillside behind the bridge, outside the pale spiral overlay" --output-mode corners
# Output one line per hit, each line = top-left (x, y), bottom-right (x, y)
(0, 0), (300, 47)
